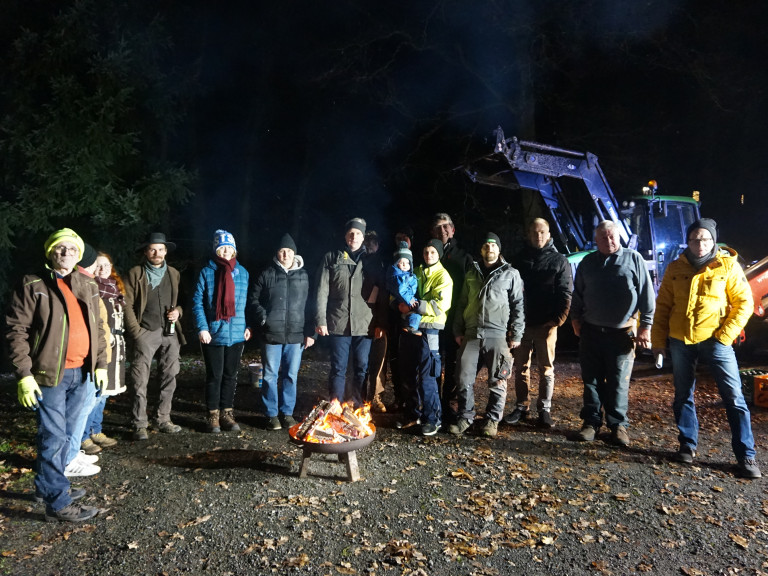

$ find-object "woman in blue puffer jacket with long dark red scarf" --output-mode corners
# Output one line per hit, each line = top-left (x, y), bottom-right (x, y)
(192, 230), (251, 434)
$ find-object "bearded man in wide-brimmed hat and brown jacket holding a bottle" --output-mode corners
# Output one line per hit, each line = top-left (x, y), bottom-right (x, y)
(125, 232), (185, 440)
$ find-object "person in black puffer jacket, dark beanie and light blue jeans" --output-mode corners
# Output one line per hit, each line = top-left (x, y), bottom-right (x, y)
(248, 234), (315, 430)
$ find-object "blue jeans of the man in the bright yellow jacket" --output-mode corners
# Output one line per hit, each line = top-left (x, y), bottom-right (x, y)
(669, 338), (755, 460)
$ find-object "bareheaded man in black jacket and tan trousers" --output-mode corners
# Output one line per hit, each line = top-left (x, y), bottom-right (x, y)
(504, 218), (573, 428)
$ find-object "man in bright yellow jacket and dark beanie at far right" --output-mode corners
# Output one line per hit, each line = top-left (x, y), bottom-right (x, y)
(651, 218), (761, 478)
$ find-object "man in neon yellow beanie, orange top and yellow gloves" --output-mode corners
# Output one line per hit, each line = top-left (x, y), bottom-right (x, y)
(6, 228), (107, 522)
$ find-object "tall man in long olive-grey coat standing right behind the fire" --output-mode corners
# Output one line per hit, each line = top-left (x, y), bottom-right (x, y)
(315, 218), (383, 407)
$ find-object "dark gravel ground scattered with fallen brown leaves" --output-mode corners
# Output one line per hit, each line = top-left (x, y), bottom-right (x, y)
(0, 349), (768, 576)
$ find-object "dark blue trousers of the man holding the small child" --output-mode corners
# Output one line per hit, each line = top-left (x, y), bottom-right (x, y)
(398, 329), (443, 426)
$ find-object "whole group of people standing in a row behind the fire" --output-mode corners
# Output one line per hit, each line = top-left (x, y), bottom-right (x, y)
(6, 213), (761, 522)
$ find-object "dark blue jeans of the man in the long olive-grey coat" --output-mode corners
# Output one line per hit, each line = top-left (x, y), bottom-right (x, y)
(328, 334), (371, 408)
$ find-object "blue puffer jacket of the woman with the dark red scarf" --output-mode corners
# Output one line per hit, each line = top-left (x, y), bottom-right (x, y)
(192, 260), (248, 346)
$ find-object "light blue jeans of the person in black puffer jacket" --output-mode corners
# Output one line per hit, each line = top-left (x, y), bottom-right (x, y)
(261, 344), (304, 418)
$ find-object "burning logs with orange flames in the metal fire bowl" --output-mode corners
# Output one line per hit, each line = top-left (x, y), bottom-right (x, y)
(291, 399), (374, 444)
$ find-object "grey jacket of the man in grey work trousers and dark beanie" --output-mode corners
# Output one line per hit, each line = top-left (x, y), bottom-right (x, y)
(453, 258), (525, 342)
